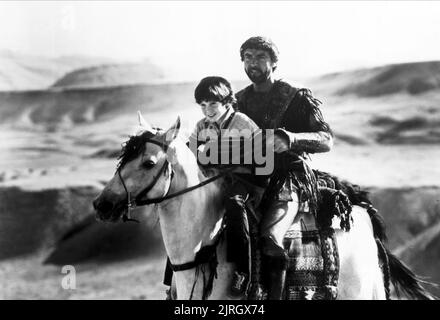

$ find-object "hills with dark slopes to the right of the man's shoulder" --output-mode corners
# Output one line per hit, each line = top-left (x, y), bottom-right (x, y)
(306, 61), (440, 146)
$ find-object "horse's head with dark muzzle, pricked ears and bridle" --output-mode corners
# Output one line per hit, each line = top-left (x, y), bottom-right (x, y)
(93, 113), (180, 222)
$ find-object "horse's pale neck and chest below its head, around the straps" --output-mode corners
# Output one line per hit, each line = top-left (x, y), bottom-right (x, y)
(160, 143), (239, 299)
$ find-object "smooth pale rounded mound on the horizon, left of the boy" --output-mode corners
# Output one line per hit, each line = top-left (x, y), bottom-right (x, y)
(52, 61), (164, 88)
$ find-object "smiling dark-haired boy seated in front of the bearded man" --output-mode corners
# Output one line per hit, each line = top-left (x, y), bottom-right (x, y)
(189, 77), (259, 296)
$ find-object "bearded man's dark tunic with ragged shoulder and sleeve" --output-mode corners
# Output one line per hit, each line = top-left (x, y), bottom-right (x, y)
(236, 81), (333, 213)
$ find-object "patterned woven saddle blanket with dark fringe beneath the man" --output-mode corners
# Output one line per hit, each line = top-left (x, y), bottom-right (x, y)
(248, 181), (352, 300)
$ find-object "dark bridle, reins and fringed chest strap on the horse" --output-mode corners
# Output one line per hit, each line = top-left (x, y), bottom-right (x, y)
(116, 132), (232, 300)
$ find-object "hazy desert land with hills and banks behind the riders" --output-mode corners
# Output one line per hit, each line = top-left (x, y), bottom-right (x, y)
(0, 57), (440, 299)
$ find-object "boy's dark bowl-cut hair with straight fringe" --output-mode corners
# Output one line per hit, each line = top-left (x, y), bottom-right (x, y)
(194, 77), (237, 105)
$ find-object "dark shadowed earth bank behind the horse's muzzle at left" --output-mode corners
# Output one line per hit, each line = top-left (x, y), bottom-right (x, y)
(0, 187), (163, 264)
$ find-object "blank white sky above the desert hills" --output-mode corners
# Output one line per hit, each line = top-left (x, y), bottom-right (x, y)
(0, 1), (440, 80)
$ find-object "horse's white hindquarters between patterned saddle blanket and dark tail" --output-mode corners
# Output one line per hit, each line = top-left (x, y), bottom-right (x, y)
(336, 206), (385, 300)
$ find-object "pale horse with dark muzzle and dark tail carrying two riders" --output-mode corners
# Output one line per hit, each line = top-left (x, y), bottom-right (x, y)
(93, 113), (432, 300)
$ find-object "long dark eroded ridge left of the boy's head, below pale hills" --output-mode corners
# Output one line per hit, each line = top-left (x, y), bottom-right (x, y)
(0, 84), (193, 130)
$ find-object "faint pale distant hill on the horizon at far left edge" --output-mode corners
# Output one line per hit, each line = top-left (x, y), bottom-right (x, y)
(0, 50), (111, 91)
